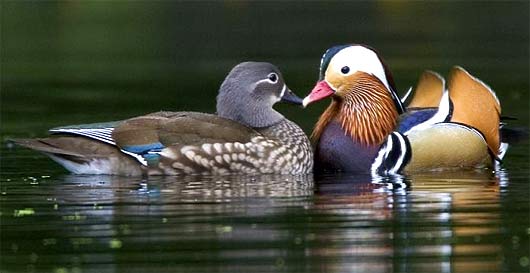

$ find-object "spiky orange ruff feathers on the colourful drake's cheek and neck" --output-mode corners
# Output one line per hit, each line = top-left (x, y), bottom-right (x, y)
(311, 81), (399, 145)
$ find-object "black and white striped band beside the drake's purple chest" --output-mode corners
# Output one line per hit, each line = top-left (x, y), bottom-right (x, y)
(371, 132), (412, 175)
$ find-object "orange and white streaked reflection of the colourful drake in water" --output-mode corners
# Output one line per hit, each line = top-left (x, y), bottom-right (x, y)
(311, 170), (508, 272)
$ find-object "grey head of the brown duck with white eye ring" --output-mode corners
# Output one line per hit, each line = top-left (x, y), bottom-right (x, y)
(217, 62), (302, 128)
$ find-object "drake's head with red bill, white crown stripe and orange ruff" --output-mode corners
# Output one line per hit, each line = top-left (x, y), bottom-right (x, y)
(303, 44), (404, 144)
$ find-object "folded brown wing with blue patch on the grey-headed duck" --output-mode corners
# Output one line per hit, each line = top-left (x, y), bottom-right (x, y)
(112, 112), (260, 165)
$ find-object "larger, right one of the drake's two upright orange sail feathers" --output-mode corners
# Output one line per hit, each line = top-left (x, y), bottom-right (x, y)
(448, 66), (501, 155)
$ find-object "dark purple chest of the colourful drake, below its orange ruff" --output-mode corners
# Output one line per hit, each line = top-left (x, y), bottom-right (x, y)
(315, 121), (379, 173)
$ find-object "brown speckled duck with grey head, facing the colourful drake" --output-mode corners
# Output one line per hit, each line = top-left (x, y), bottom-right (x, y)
(14, 62), (313, 175)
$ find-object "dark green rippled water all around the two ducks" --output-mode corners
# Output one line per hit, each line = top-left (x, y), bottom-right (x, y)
(0, 1), (530, 272)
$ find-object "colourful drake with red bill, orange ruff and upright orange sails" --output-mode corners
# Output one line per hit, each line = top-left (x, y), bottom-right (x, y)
(303, 45), (507, 174)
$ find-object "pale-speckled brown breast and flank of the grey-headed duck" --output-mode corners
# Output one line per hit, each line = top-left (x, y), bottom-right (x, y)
(134, 113), (313, 175)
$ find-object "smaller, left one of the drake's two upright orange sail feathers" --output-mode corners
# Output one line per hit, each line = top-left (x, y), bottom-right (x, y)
(408, 70), (445, 108)
